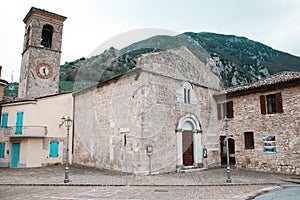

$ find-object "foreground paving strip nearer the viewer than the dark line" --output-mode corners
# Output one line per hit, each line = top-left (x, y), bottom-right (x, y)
(0, 185), (278, 200)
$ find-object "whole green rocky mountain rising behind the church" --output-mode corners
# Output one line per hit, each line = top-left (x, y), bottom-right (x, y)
(60, 32), (300, 91)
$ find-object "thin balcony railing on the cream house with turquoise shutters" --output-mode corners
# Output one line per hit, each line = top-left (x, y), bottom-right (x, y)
(0, 126), (47, 137)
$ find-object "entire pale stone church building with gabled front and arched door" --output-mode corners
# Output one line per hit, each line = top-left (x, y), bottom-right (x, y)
(74, 47), (220, 173)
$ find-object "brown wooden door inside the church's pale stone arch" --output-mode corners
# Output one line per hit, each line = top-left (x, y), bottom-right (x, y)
(182, 131), (194, 166)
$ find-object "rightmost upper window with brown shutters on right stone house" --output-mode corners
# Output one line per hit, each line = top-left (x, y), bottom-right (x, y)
(260, 93), (283, 114)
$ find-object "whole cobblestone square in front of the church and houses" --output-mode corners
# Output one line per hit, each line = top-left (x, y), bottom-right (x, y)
(0, 165), (300, 200)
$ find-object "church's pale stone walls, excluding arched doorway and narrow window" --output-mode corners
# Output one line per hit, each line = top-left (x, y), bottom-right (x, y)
(74, 47), (220, 173)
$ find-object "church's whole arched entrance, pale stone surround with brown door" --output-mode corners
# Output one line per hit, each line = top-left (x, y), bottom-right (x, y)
(176, 114), (203, 169)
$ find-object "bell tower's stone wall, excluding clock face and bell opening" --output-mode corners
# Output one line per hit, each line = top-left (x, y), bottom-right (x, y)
(18, 12), (63, 98)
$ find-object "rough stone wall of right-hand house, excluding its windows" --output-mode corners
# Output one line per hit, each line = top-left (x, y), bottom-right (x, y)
(221, 85), (300, 174)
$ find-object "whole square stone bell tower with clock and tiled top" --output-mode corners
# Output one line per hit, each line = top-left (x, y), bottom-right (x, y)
(18, 7), (67, 98)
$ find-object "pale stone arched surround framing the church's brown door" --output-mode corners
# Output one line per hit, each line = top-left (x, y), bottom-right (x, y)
(176, 113), (203, 169)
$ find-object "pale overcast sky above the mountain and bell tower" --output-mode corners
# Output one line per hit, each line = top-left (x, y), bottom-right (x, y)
(0, 0), (300, 82)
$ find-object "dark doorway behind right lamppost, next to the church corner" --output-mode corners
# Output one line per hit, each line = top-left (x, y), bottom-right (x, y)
(220, 136), (235, 166)
